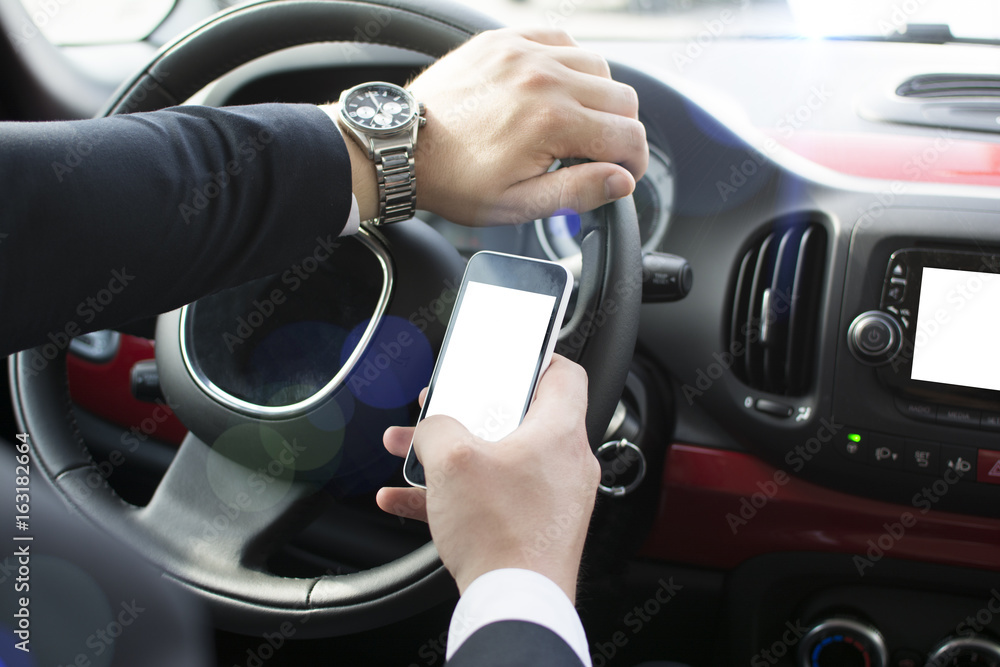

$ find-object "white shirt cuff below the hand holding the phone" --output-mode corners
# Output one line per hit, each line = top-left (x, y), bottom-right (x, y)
(445, 568), (592, 667)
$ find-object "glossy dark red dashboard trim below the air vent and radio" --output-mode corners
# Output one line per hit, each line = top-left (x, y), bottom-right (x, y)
(641, 444), (1000, 570)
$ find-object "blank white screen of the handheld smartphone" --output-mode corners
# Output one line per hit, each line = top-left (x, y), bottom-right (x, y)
(426, 282), (556, 442)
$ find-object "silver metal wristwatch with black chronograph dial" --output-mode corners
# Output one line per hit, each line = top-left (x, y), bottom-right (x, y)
(339, 81), (427, 225)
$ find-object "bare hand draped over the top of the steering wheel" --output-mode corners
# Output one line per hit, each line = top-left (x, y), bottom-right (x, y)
(409, 29), (649, 225)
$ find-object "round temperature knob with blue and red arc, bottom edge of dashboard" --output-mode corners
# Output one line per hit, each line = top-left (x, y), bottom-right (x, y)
(798, 618), (889, 667)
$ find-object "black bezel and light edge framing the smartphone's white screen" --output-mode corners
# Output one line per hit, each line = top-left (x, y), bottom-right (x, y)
(403, 250), (573, 488)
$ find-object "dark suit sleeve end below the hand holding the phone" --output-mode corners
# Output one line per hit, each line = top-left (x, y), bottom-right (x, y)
(447, 621), (583, 667)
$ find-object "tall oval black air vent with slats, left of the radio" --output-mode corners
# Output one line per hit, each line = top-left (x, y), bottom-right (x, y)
(729, 218), (826, 396)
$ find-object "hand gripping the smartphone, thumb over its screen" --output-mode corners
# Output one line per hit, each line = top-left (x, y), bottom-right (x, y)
(376, 355), (601, 600)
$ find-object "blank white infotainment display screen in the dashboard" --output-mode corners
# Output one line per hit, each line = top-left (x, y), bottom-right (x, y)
(910, 266), (1000, 390)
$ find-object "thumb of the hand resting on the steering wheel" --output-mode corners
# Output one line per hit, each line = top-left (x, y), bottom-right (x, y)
(493, 162), (635, 222)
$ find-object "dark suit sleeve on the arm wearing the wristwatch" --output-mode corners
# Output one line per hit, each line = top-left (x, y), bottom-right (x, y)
(0, 104), (351, 355)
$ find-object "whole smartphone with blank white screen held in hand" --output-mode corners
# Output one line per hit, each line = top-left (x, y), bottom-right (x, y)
(403, 251), (573, 488)
